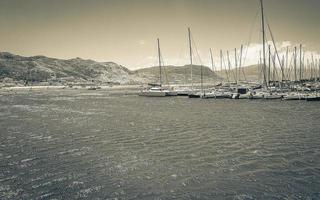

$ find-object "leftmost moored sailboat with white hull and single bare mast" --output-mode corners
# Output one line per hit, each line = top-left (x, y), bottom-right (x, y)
(139, 38), (171, 97)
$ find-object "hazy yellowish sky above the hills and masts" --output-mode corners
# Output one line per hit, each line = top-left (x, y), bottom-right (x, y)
(0, 0), (320, 69)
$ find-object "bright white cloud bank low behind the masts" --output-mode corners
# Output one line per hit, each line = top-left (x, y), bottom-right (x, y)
(134, 41), (320, 70)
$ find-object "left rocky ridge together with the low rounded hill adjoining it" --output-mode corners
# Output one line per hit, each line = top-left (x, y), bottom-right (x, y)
(0, 52), (225, 84)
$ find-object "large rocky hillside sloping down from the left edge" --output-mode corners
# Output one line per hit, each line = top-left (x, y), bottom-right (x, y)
(0, 53), (139, 84)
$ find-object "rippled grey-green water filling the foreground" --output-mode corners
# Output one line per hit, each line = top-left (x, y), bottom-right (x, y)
(0, 90), (320, 199)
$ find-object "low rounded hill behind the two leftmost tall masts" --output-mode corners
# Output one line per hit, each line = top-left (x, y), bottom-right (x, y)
(134, 65), (221, 84)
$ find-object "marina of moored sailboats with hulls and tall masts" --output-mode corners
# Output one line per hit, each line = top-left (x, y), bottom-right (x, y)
(140, 0), (320, 101)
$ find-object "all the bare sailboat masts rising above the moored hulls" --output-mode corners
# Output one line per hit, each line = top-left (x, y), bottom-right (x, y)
(157, 0), (320, 89)
